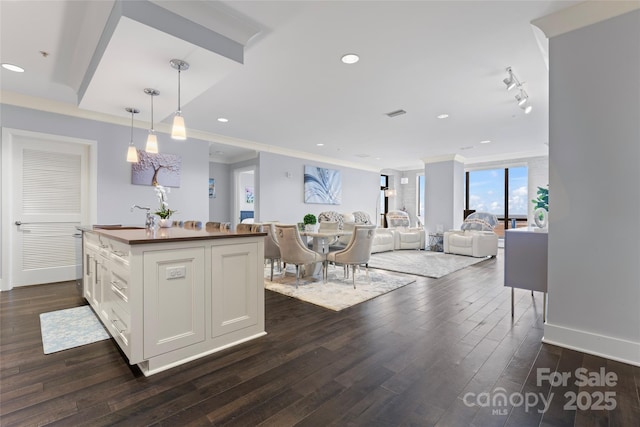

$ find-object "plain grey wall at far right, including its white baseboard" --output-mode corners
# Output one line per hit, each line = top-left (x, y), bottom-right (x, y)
(544, 11), (640, 365)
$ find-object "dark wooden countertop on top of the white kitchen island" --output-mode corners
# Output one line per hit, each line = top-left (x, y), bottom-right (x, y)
(83, 227), (267, 245)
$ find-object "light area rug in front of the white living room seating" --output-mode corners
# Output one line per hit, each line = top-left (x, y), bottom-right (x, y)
(369, 250), (488, 279)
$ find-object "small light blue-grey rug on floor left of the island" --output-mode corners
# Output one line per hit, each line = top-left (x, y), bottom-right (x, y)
(40, 305), (109, 354)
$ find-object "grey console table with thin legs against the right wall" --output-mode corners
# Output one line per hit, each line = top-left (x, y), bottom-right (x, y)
(504, 227), (548, 321)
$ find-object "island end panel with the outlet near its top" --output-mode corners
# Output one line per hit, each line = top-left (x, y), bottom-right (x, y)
(143, 247), (206, 358)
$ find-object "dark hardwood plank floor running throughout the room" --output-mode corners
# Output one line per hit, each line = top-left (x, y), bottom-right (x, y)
(0, 252), (640, 427)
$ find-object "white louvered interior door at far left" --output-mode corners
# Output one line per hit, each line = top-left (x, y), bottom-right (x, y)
(10, 132), (89, 286)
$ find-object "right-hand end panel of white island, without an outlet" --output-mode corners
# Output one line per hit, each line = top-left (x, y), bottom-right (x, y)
(211, 243), (264, 337)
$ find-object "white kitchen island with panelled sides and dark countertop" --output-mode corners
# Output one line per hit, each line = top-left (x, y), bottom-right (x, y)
(83, 227), (266, 375)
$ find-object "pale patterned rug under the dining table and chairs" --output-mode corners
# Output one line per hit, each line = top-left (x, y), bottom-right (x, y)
(264, 267), (416, 311)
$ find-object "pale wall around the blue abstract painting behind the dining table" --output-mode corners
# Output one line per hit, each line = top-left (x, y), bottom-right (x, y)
(256, 153), (380, 224)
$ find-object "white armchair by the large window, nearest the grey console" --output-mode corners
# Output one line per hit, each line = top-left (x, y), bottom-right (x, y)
(442, 212), (498, 257)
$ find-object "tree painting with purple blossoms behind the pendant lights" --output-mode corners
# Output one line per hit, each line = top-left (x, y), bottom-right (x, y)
(131, 150), (182, 187)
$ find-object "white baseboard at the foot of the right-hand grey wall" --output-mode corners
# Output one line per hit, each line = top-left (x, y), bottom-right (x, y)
(542, 323), (640, 366)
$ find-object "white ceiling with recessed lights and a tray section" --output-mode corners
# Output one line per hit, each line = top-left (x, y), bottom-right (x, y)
(0, 0), (579, 170)
